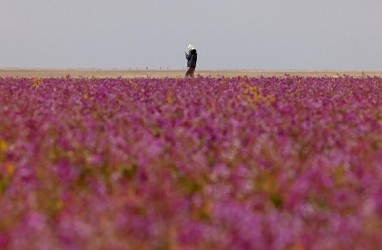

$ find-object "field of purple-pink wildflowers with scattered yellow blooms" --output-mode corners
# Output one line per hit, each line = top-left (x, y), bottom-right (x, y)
(0, 76), (382, 250)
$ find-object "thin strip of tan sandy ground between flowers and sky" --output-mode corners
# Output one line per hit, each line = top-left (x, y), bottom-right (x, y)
(0, 68), (382, 78)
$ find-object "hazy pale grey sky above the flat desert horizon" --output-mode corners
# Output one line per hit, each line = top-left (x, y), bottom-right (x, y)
(0, 0), (382, 70)
